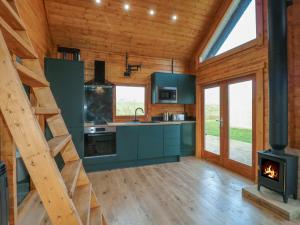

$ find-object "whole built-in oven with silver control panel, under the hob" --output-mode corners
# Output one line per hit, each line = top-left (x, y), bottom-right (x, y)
(84, 126), (117, 158)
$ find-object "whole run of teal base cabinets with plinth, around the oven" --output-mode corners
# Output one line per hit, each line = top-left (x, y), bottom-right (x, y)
(83, 125), (180, 172)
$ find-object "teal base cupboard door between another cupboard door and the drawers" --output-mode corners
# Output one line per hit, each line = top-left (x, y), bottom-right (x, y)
(138, 125), (164, 159)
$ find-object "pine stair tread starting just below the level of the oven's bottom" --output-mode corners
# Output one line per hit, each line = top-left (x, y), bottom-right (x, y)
(61, 160), (82, 197)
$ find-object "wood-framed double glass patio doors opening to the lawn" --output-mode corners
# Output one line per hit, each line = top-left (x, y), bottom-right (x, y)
(202, 77), (255, 178)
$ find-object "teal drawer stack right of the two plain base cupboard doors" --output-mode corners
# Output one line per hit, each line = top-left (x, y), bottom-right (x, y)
(164, 125), (181, 156)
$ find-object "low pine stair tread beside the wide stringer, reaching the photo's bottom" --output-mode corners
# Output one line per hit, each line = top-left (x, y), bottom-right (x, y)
(73, 184), (92, 225)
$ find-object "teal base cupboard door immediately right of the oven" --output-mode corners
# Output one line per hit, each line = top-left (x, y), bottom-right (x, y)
(116, 126), (139, 161)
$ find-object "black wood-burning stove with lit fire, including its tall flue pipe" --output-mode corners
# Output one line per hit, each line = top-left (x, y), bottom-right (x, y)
(258, 0), (298, 203)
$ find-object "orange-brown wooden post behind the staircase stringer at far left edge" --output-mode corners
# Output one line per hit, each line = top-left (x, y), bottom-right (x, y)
(0, 113), (18, 225)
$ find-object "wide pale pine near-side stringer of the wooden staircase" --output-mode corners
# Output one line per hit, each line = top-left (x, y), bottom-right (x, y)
(0, 31), (82, 225)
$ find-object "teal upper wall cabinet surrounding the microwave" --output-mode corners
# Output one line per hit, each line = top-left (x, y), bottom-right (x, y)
(151, 73), (196, 105)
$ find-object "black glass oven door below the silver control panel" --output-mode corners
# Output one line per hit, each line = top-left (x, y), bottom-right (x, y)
(84, 132), (117, 157)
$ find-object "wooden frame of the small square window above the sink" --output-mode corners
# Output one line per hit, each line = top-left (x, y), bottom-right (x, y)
(113, 83), (148, 122)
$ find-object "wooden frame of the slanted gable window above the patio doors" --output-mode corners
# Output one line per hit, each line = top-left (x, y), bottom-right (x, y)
(196, 0), (264, 66)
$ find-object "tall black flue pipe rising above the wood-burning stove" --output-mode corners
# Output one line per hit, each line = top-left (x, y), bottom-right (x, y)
(268, 0), (291, 154)
